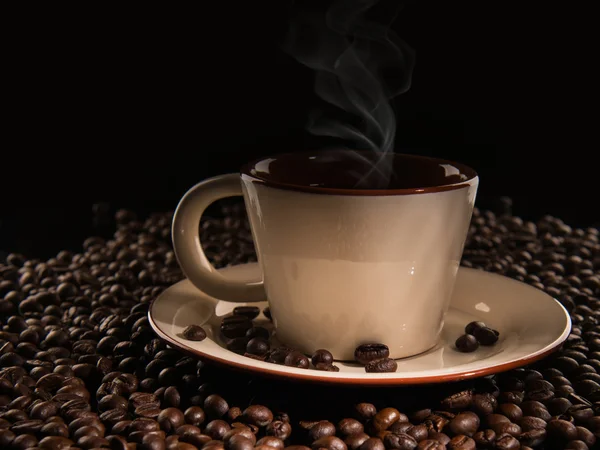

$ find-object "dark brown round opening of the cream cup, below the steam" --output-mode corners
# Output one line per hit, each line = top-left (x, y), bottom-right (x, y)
(242, 150), (476, 191)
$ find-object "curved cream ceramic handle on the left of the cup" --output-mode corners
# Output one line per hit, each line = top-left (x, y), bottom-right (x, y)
(172, 174), (266, 303)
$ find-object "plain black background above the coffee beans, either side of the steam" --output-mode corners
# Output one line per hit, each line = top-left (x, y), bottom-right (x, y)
(0, 0), (600, 256)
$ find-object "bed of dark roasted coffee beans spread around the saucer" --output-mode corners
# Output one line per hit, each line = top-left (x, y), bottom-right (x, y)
(0, 203), (600, 450)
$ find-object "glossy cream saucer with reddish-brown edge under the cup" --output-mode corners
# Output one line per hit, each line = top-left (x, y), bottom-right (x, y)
(148, 263), (571, 386)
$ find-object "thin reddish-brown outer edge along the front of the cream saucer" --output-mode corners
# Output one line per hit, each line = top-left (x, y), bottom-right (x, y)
(148, 298), (571, 386)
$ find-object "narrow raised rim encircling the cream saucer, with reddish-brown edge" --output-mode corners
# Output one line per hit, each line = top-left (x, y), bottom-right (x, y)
(147, 263), (572, 386)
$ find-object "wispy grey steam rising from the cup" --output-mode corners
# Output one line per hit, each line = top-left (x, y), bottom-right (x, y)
(283, 0), (414, 188)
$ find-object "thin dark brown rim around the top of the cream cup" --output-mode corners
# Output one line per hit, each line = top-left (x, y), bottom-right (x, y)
(240, 151), (479, 197)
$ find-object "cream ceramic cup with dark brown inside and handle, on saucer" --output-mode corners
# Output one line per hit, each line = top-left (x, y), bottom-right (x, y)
(173, 151), (479, 360)
